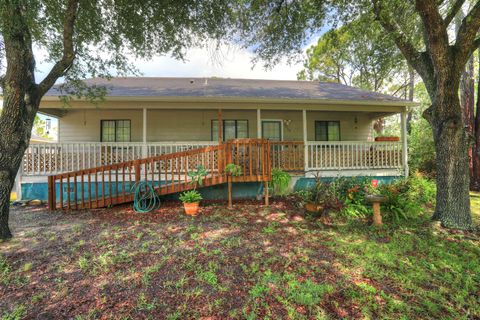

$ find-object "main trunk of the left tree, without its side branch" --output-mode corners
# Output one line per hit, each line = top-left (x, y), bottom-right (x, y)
(0, 3), (40, 239)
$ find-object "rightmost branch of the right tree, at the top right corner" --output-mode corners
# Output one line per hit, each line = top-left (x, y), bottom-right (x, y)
(454, 1), (480, 68)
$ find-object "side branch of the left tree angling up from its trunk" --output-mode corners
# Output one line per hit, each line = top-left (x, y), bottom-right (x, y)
(38, 0), (79, 98)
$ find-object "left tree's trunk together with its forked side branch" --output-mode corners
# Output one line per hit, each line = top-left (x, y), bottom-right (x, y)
(0, 0), (79, 239)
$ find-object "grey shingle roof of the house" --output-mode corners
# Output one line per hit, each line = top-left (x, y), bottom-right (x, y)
(47, 77), (409, 103)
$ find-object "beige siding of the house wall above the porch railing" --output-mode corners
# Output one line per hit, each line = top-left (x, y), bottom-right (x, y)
(59, 109), (372, 142)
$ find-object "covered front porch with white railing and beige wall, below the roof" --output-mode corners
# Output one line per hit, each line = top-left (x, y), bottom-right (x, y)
(21, 107), (408, 181)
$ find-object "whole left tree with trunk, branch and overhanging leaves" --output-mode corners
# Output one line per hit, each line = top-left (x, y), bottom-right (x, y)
(0, 0), (229, 239)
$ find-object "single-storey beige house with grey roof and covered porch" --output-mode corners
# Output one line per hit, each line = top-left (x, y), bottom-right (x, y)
(16, 77), (416, 205)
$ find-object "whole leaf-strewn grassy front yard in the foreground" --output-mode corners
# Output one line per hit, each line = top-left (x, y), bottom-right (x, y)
(0, 199), (480, 319)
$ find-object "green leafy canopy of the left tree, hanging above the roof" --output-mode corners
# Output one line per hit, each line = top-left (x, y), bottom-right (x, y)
(0, 0), (235, 94)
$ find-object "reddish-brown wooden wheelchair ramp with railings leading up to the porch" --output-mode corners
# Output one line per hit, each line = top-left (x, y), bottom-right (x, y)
(48, 139), (271, 210)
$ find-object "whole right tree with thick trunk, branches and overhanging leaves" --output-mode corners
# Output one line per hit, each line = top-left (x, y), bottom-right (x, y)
(234, 0), (480, 229)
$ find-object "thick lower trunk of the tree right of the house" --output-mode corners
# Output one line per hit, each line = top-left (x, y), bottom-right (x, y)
(427, 87), (472, 229)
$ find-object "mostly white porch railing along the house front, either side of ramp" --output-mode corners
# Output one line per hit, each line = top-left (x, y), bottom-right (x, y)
(21, 141), (406, 176)
